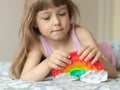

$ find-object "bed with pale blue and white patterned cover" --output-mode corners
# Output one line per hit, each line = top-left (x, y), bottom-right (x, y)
(0, 61), (120, 90)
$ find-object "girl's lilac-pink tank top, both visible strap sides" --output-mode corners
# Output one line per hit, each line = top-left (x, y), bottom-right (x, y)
(40, 25), (81, 57)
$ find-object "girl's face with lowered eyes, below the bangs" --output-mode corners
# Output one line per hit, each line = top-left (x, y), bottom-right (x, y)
(35, 5), (70, 40)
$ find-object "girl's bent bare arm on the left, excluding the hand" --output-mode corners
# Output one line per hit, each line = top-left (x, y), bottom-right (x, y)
(20, 44), (51, 81)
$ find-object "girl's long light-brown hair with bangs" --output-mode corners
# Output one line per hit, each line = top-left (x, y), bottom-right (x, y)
(10, 0), (79, 79)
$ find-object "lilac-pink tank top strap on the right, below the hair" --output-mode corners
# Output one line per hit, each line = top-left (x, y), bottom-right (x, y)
(71, 25), (81, 51)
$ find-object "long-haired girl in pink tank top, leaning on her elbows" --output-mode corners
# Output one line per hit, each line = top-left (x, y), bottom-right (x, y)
(10, 0), (117, 81)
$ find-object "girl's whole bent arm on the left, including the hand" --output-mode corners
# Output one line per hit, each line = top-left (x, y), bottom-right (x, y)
(21, 41), (71, 81)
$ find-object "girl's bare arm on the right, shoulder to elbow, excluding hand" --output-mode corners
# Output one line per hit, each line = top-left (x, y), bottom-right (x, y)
(76, 27), (117, 78)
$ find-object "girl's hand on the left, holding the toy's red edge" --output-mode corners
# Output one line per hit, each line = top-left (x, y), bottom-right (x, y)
(48, 50), (71, 70)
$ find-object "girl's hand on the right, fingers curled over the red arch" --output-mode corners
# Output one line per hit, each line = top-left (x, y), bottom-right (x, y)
(78, 45), (102, 64)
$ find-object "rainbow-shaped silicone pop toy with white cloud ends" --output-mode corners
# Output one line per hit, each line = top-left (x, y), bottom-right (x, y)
(52, 51), (108, 83)
